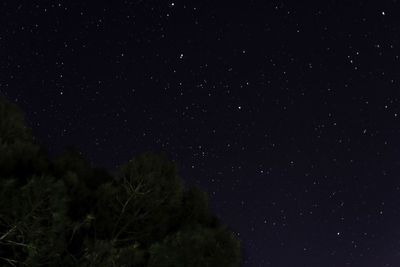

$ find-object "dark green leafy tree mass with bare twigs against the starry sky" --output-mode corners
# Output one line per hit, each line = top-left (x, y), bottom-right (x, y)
(0, 96), (240, 267)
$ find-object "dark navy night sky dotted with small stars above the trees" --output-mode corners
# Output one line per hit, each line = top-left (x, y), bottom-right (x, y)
(0, 0), (400, 267)
